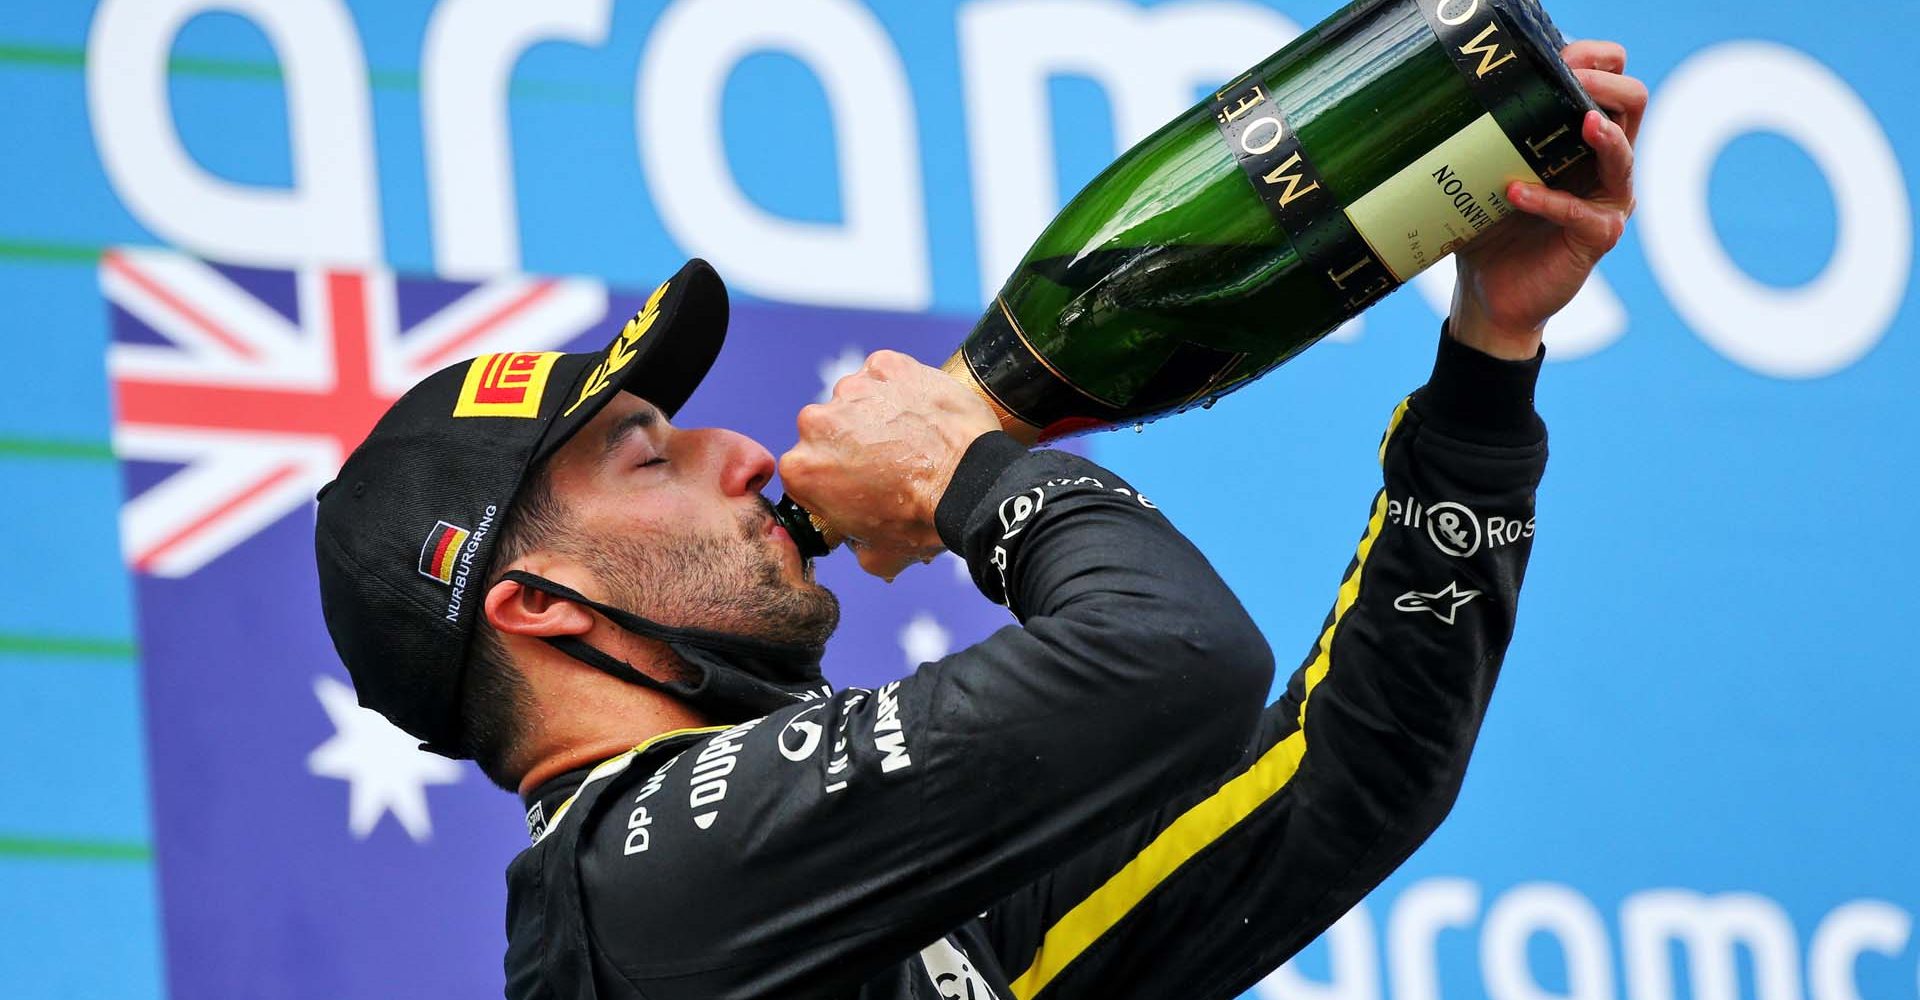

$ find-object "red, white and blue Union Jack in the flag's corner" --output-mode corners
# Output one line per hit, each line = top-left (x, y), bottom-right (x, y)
(100, 248), (609, 576)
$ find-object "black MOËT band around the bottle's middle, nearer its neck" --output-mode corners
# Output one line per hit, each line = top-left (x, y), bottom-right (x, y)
(1212, 75), (1400, 313)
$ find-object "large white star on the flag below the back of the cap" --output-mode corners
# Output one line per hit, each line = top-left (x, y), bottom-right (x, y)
(307, 676), (461, 843)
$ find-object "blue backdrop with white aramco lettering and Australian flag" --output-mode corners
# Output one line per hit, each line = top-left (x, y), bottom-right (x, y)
(0, 0), (1920, 1000)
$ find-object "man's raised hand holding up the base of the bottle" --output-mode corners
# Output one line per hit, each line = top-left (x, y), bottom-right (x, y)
(1450, 42), (1647, 361)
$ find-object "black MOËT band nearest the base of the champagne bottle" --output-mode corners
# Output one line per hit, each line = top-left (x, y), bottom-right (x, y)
(1415, 0), (1597, 192)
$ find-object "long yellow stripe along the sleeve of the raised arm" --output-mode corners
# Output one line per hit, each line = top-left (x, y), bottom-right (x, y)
(1014, 401), (1407, 1000)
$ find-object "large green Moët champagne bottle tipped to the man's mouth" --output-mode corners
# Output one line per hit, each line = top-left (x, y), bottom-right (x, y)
(781, 0), (1596, 553)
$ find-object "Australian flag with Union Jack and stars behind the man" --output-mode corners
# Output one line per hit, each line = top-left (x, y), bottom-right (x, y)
(100, 248), (1008, 1000)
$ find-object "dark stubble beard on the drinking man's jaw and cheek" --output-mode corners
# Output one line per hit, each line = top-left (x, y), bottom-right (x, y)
(578, 509), (839, 647)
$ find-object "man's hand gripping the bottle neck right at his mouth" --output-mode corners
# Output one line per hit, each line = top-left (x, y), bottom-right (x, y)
(780, 351), (1000, 580)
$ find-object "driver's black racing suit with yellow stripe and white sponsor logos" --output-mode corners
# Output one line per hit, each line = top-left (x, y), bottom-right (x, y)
(507, 336), (1546, 1000)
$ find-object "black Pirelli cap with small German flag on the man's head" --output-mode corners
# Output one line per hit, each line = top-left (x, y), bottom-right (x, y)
(313, 259), (728, 756)
